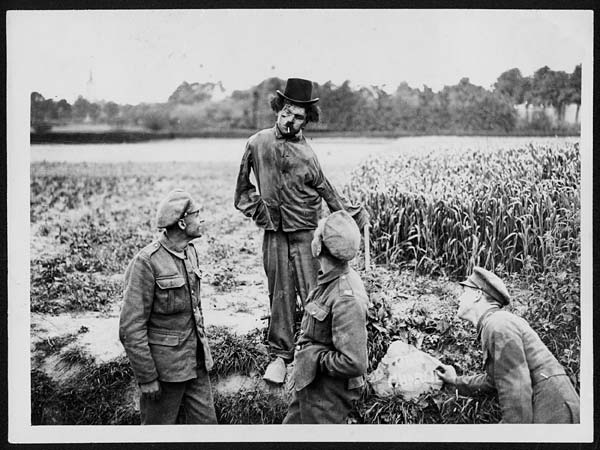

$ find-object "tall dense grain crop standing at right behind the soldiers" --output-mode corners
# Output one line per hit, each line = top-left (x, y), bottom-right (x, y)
(347, 144), (581, 276)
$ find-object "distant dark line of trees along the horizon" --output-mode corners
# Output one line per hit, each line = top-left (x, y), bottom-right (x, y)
(31, 65), (581, 134)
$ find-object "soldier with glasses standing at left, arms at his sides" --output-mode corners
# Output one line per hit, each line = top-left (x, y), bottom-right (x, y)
(119, 189), (217, 425)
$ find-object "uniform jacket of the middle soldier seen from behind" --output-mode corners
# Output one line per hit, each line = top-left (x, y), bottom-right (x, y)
(294, 263), (369, 391)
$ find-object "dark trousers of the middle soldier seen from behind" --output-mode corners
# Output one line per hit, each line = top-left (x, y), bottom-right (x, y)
(283, 373), (361, 424)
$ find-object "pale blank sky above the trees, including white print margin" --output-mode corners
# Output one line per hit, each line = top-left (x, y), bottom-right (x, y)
(7, 9), (593, 104)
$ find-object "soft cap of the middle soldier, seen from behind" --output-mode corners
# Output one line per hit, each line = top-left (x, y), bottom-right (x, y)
(311, 210), (360, 261)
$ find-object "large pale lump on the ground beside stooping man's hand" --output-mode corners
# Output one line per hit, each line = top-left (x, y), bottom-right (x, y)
(367, 341), (443, 400)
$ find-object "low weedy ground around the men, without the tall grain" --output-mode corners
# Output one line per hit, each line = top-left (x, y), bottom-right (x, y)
(30, 142), (579, 424)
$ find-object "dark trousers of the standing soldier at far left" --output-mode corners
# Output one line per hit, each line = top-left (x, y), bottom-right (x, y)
(140, 369), (217, 425)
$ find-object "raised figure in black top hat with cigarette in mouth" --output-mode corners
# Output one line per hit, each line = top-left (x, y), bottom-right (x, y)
(234, 78), (369, 383)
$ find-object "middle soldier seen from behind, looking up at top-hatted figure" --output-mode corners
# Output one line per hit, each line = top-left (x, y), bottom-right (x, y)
(283, 211), (369, 424)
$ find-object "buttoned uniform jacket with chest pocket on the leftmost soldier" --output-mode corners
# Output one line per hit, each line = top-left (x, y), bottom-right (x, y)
(119, 234), (212, 383)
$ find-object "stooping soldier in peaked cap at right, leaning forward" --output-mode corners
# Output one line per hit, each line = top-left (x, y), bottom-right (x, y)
(437, 267), (579, 423)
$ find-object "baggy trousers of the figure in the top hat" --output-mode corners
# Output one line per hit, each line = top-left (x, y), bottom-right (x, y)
(263, 230), (319, 361)
